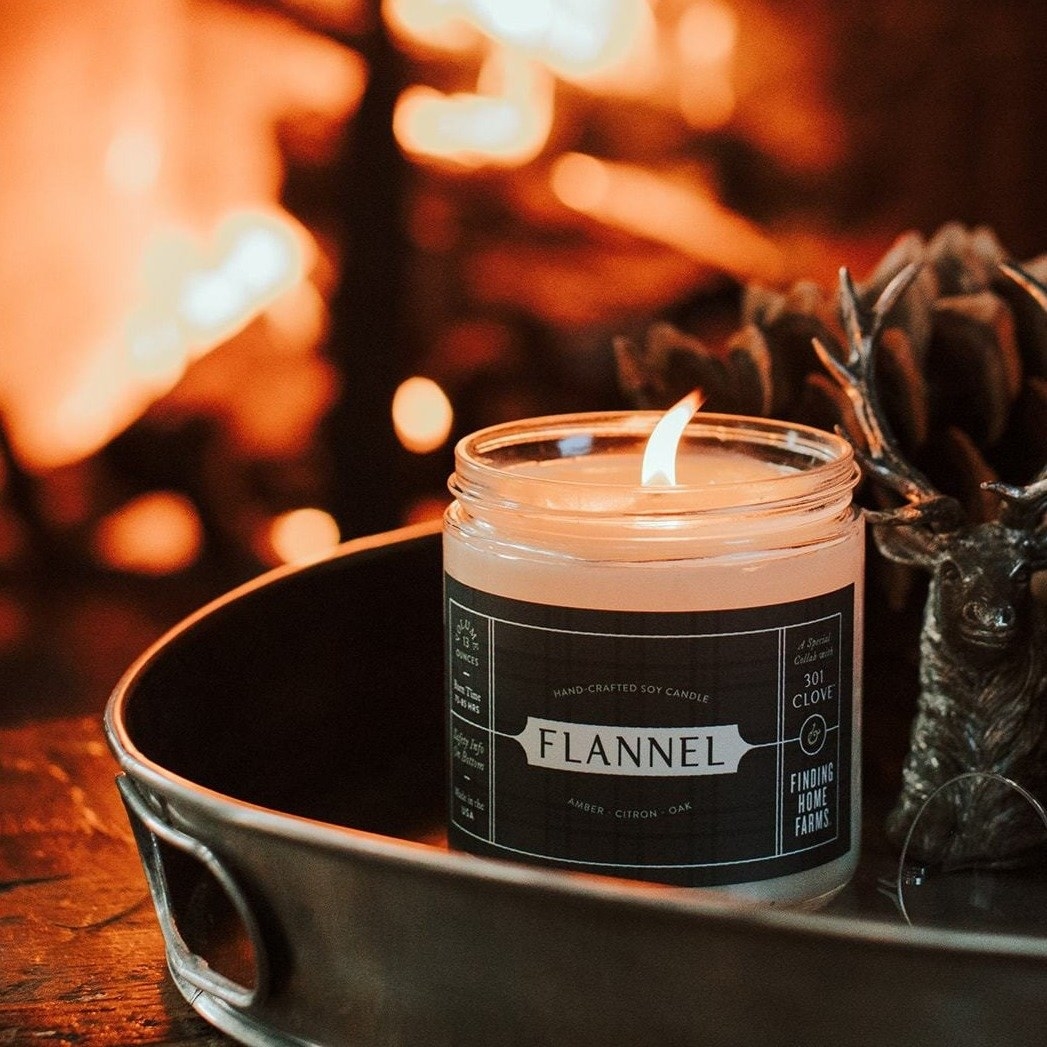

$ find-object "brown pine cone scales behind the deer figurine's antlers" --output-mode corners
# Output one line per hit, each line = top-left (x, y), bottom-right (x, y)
(616, 224), (1047, 569)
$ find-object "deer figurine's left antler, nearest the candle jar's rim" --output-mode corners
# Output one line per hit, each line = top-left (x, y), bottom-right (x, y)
(812, 263), (961, 532)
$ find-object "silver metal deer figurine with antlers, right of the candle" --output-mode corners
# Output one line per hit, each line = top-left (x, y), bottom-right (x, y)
(815, 264), (1047, 867)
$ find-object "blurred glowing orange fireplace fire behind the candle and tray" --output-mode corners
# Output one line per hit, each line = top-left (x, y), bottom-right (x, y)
(0, 0), (1047, 721)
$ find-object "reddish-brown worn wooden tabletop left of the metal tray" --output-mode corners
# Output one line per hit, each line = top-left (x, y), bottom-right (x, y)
(0, 715), (232, 1047)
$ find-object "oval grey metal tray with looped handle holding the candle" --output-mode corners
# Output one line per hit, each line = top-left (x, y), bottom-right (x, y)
(106, 526), (1047, 1047)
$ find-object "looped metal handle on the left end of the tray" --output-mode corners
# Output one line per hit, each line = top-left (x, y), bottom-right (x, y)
(116, 774), (269, 1009)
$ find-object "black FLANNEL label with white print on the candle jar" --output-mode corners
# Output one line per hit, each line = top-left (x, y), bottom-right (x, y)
(446, 576), (854, 886)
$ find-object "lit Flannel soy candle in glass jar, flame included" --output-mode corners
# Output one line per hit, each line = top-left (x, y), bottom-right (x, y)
(444, 402), (864, 905)
